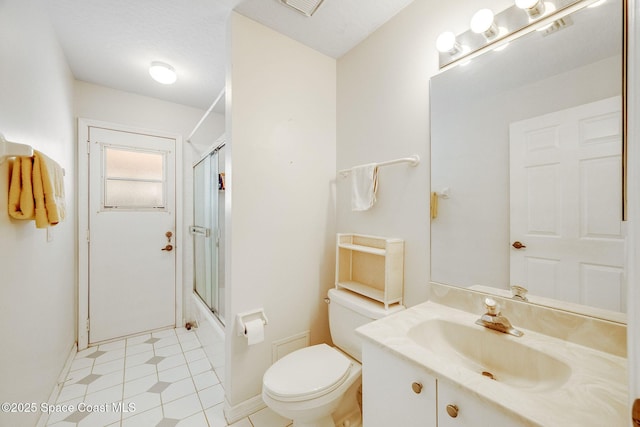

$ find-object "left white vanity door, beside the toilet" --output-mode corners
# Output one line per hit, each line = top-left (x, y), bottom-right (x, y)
(362, 343), (436, 427)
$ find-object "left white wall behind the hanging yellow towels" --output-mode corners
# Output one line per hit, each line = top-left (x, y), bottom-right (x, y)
(0, 0), (76, 427)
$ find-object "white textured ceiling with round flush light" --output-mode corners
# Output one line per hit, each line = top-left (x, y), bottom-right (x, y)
(45, 0), (413, 111)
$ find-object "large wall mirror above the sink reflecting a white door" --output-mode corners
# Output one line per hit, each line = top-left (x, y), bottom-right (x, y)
(431, 0), (626, 319)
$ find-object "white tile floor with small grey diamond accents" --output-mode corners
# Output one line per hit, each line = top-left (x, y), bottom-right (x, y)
(47, 328), (291, 427)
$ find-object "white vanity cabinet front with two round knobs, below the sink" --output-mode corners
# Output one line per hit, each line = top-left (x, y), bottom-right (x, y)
(362, 341), (528, 427)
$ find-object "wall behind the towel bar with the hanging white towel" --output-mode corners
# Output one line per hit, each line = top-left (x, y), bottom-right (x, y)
(337, 0), (510, 305)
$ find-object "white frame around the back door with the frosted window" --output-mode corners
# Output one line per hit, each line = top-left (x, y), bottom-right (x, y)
(76, 117), (185, 350)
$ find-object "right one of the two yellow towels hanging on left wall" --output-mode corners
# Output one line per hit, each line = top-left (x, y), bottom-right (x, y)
(33, 150), (66, 228)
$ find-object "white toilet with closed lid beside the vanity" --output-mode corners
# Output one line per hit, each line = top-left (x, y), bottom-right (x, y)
(262, 289), (404, 427)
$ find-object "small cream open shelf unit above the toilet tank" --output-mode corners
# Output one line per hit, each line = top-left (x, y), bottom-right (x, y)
(336, 233), (404, 308)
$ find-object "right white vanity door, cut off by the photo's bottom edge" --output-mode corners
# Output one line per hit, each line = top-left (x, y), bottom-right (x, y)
(438, 381), (526, 427)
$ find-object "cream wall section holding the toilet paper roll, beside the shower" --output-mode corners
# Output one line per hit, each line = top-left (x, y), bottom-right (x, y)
(225, 13), (336, 418)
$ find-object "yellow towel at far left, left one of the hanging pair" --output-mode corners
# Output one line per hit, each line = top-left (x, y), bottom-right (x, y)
(9, 157), (34, 219)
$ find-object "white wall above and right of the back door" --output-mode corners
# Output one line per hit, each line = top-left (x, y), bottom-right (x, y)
(75, 81), (224, 320)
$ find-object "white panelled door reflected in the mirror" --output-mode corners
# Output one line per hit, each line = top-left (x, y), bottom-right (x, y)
(510, 97), (626, 311)
